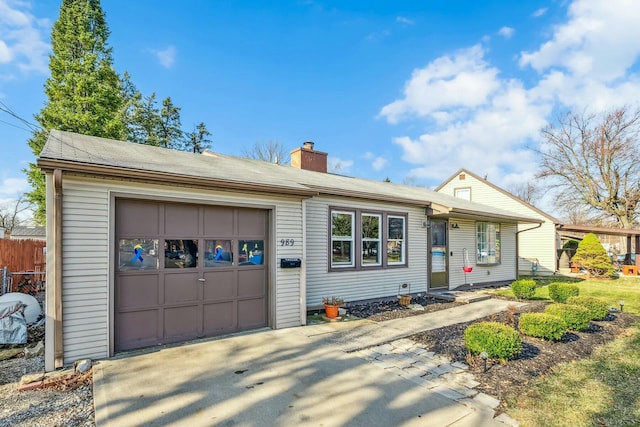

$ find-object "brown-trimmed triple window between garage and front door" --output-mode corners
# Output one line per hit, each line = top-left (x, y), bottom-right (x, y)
(329, 208), (407, 270)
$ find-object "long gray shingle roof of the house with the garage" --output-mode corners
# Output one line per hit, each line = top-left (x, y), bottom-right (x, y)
(38, 130), (540, 223)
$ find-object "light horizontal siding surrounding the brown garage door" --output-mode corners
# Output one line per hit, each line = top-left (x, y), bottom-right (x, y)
(57, 176), (303, 364)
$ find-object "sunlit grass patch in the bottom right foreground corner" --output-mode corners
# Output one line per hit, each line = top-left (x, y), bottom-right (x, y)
(507, 328), (640, 427)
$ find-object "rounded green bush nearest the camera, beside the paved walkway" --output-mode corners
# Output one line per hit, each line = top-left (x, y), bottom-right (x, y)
(464, 322), (522, 360)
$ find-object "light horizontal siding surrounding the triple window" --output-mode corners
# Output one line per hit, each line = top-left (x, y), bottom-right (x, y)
(306, 197), (427, 307)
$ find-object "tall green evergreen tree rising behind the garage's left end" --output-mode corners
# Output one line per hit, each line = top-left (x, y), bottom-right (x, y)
(26, 0), (126, 224)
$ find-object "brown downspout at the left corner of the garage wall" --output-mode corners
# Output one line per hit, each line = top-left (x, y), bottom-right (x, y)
(52, 169), (64, 369)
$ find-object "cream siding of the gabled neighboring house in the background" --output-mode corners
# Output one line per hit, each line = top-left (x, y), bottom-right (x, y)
(439, 174), (557, 275)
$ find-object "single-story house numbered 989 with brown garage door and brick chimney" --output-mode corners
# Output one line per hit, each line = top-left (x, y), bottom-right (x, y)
(38, 131), (541, 370)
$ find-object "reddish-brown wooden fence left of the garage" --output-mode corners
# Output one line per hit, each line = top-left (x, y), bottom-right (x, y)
(0, 239), (46, 291)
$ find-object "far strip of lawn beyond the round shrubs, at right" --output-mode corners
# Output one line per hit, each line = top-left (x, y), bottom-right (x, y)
(496, 277), (640, 315)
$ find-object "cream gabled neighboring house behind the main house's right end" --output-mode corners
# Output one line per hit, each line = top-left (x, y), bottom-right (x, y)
(435, 169), (560, 275)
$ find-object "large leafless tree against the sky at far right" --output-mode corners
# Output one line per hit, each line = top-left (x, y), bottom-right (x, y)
(538, 107), (640, 228)
